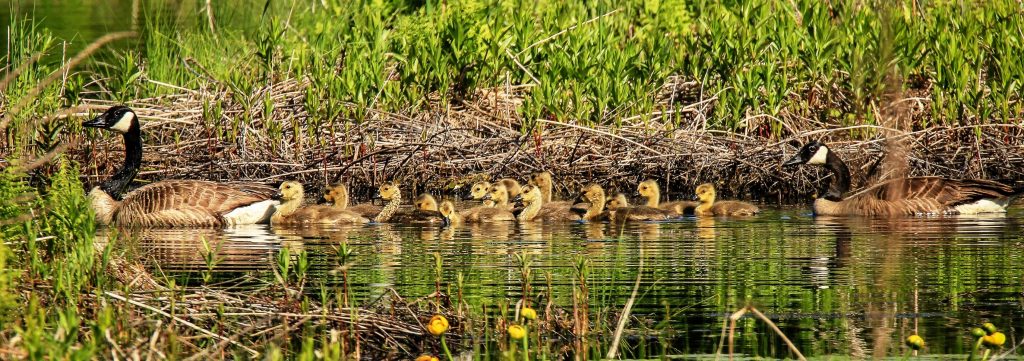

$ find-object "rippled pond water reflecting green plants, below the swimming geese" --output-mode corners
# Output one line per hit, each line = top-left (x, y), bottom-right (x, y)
(101, 208), (1024, 357)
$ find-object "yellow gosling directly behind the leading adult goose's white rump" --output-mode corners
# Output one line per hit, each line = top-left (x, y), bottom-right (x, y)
(270, 181), (370, 225)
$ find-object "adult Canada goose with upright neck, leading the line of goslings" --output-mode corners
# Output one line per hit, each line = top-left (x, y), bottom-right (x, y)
(82, 105), (279, 227)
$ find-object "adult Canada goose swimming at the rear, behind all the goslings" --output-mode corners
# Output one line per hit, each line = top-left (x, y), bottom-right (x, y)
(782, 141), (1020, 213)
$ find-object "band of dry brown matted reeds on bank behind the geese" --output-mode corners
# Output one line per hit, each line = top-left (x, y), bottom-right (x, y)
(72, 79), (1024, 201)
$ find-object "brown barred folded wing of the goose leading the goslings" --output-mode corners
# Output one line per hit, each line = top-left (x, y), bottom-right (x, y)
(116, 180), (274, 227)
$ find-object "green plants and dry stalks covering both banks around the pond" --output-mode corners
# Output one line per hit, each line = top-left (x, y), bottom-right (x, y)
(0, 0), (1024, 359)
